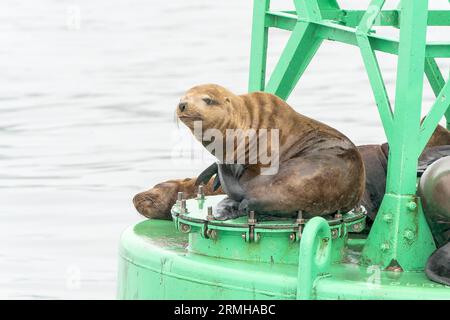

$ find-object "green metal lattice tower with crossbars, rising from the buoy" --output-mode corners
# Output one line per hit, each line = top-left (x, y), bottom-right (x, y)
(249, 0), (450, 271)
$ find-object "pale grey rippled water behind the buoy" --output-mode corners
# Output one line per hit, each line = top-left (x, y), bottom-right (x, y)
(0, 0), (449, 299)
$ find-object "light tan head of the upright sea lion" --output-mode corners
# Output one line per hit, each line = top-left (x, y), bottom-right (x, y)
(176, 84), (236, 131)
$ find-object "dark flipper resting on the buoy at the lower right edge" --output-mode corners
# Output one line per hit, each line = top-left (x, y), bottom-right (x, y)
(425, 242), (450, 286)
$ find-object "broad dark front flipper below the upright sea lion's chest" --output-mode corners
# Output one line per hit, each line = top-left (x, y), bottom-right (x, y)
(218, 163), (245, 201)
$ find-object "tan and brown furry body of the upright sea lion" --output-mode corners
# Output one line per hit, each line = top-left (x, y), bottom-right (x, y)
(173, 85), (365, 218)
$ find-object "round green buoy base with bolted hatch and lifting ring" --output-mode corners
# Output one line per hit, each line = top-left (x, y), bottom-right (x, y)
(118, 192), (450, 299)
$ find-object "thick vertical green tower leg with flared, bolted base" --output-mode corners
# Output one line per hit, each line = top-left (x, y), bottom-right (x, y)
(363, 0), (435, 270)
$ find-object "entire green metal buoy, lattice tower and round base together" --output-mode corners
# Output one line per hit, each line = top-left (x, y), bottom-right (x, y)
(118, 0), (450, 299)
